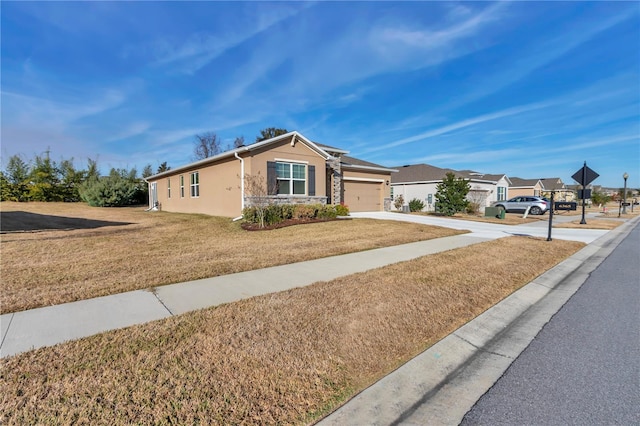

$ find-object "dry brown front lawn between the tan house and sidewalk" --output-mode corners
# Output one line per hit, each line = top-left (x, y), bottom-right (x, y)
(0, 202), (460, 313)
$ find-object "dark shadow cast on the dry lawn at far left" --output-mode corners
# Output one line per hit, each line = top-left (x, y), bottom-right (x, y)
(0, 211), (131, 234)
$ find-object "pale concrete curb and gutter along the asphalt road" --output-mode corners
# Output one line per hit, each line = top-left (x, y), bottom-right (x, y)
(317, 216), (640, 426)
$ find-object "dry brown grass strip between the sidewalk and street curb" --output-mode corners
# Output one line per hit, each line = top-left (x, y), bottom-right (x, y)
(0, 237), (583, 424)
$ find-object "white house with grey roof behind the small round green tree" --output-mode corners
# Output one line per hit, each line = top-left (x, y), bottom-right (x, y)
(391, 164), (511, 212)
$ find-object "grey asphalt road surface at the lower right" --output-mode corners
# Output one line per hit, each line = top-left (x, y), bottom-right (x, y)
(461, 221), (640, 425)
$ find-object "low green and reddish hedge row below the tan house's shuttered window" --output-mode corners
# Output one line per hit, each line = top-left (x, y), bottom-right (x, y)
(242, 204), (349, 226)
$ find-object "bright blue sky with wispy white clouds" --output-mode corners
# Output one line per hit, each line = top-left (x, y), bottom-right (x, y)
(1, 1), (640, 188)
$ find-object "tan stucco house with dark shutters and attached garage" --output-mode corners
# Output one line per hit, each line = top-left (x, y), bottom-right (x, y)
(146, 132), (395, 218)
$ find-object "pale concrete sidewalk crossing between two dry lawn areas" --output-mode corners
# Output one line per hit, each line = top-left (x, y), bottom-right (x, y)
(0, 233), (490, 357)
